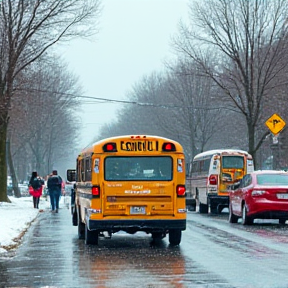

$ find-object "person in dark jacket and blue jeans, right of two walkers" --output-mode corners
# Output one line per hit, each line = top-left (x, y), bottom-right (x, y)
(47, 170), (63, 213)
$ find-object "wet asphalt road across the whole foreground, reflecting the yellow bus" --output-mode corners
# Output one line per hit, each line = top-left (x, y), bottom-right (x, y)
(0, 208), (288, 288)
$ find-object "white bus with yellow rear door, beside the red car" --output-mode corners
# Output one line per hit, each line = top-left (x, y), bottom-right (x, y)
(190, 149), (254, 213)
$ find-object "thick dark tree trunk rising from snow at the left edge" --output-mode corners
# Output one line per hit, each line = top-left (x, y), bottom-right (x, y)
(0, 118), (10, 202)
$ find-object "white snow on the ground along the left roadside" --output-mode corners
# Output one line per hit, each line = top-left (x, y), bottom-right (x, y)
(0, 196), (68, 254)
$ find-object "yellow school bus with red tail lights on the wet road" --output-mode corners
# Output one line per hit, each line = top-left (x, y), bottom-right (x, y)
(67, 135), (186, 245)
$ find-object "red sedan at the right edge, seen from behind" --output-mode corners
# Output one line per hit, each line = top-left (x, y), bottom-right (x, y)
(229, 170), (288, 225)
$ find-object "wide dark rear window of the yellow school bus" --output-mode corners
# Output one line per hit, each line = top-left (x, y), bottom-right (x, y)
(104, 156), (173, 181)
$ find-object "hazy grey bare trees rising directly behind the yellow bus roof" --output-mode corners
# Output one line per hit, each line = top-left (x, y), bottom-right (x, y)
(96, 67), (221, 158)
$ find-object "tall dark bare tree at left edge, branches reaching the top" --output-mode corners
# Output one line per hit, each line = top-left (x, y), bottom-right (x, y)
(0, 0), (100, 201)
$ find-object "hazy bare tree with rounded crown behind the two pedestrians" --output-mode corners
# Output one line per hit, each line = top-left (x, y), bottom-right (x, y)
(9, 57), (81, 179)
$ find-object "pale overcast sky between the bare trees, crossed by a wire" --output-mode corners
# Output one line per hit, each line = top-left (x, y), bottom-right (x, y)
(64, 0), (189, 146)
